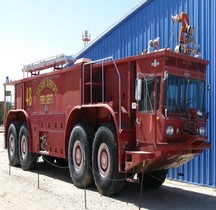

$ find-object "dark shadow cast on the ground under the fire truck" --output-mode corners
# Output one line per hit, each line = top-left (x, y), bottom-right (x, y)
(26, 162), (216, 210)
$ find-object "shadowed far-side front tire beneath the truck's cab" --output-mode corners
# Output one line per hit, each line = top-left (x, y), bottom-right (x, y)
(138, 170), (167, 188)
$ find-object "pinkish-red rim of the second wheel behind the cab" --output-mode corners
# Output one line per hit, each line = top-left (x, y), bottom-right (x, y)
(73, 140), (83, 171)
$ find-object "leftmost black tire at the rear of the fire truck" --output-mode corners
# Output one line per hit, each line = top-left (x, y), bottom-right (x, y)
(7, 122), (20, 166)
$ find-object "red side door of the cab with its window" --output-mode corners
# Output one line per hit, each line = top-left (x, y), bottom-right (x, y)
(136, 76), (161, 143)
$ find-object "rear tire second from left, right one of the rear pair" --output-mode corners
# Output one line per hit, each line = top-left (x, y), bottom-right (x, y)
(19, 123), (37, 171)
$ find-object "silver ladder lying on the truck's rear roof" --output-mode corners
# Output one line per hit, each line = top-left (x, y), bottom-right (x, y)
(22, 54), (75, 76)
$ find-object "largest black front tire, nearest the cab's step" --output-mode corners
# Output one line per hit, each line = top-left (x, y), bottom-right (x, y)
(92, 123), (125, 196)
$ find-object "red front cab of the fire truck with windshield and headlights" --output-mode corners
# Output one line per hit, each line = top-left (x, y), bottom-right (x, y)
(128, 50), (210, 171)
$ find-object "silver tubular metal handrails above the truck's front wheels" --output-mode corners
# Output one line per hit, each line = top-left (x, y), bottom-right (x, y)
(82, 56), (122, 132)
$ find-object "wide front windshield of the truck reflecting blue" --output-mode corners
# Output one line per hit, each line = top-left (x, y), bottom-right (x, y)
(164, 75), (205, 112)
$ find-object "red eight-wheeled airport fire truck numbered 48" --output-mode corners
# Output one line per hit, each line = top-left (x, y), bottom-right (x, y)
(4, 49), (210, 196)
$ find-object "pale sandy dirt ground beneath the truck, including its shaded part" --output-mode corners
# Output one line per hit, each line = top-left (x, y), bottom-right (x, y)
(0, 132), (216, 210)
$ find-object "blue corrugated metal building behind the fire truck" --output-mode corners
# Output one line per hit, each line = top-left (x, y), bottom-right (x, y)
(76, 0), (216, 187)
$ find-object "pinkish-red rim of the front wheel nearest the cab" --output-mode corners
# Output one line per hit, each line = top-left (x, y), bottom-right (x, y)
(97, 143), (110, 177)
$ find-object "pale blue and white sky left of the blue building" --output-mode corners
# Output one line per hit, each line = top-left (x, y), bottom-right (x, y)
(0, 0), (142, 101)
